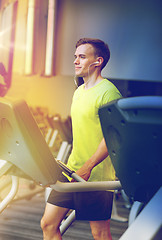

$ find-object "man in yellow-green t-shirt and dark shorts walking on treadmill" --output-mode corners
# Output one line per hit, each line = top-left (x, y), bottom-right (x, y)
(41, 38), (121, 240)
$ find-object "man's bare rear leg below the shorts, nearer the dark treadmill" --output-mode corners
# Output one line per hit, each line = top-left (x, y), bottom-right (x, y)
(90, 219), (112, 240)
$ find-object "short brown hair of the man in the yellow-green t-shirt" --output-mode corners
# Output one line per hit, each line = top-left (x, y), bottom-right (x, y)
(76, 38), (110, 70)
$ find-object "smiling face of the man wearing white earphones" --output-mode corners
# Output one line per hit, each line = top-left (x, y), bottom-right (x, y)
(74, 44), (97, 77)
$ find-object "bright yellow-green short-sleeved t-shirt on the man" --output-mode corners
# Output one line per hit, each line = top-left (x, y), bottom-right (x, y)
(67, 79), (121, 181)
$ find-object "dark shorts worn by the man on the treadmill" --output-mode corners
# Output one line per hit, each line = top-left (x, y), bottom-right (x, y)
(47, 174), (113, 221)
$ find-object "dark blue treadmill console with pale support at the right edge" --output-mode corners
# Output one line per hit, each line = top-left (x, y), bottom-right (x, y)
(99, 96), (162, 240)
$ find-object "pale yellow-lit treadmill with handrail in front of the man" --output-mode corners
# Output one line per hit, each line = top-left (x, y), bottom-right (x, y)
(0, 98), (121, 234)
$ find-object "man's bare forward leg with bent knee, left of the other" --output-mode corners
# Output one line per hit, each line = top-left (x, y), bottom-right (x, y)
(41, 203), (69, 240)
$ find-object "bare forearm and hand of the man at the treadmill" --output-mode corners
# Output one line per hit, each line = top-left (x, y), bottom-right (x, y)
(72, 138), (109, 181)
